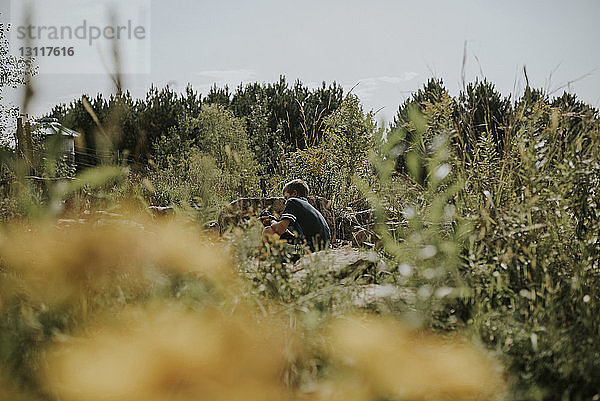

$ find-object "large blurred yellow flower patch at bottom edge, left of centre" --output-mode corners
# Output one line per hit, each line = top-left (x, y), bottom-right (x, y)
(46, 307), (288, 401)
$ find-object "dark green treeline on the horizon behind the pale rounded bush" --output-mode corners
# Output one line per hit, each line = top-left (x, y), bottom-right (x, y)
(50, 76), (343, 174)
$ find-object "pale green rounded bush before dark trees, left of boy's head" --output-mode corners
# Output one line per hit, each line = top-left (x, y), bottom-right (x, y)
(148, 105), (258, 209)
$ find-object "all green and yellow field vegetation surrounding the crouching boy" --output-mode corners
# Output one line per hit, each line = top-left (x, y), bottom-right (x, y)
(0, 23), (600, 401)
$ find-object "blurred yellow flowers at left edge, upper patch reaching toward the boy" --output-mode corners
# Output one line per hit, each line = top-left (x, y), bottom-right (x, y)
(0, 218), (233, 303)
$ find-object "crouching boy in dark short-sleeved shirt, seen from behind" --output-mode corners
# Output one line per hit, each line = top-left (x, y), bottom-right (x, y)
(262, 180), (331, 252)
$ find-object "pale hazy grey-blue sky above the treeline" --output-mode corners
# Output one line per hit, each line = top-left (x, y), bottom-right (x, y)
(0, 0), (600, 126)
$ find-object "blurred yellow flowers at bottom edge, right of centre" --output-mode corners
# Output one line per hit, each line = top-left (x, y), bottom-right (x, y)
(318, 316), (504, 400)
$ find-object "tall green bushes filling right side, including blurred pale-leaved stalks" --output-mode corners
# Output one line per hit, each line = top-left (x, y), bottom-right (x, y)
(372, 81), (600, 399)
